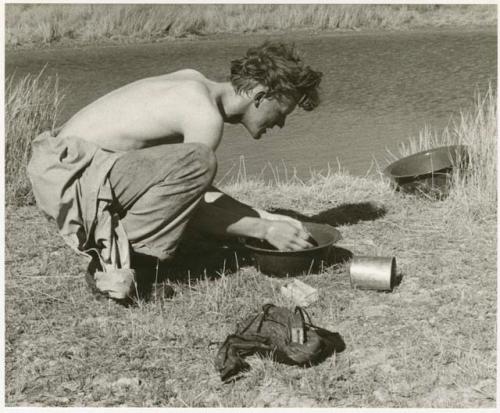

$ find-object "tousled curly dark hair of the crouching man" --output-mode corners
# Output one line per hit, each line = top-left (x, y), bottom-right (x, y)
(230, 42), (323, 111)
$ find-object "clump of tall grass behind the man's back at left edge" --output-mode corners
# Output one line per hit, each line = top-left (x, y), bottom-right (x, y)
(5, 70), (63, 205)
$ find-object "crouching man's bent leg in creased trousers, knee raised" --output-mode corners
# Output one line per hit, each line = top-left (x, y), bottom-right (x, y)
(109, 143), (217, 260)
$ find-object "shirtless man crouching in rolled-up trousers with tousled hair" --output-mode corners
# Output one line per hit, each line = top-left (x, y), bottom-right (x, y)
(28, 43), (321, 299)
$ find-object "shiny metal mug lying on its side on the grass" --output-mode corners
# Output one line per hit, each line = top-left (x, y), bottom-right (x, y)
(349, 257), (396, 291)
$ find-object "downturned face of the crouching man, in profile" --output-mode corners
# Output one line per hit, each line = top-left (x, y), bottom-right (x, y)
(242, 95), (297, 139)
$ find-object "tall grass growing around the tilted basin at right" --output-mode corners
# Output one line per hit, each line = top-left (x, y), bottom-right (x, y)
(394, 84), (497, 217)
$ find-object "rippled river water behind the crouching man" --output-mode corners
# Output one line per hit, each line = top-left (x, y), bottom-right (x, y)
(5, 31), (497, 179)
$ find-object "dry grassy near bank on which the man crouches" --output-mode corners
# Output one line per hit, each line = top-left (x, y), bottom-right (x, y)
(5, 70), (497, 402)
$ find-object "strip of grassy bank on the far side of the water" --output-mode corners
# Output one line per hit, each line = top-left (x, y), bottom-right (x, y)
(5, 4), (497, 47)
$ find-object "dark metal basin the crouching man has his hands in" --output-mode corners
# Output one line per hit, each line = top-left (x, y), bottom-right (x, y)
(246, 222), (342, 277)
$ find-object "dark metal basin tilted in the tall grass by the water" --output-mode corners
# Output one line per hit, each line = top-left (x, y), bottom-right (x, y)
(384, 145), (468, 195)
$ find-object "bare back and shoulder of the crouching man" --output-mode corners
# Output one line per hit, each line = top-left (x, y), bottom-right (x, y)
(59, 69), (224, 152)
